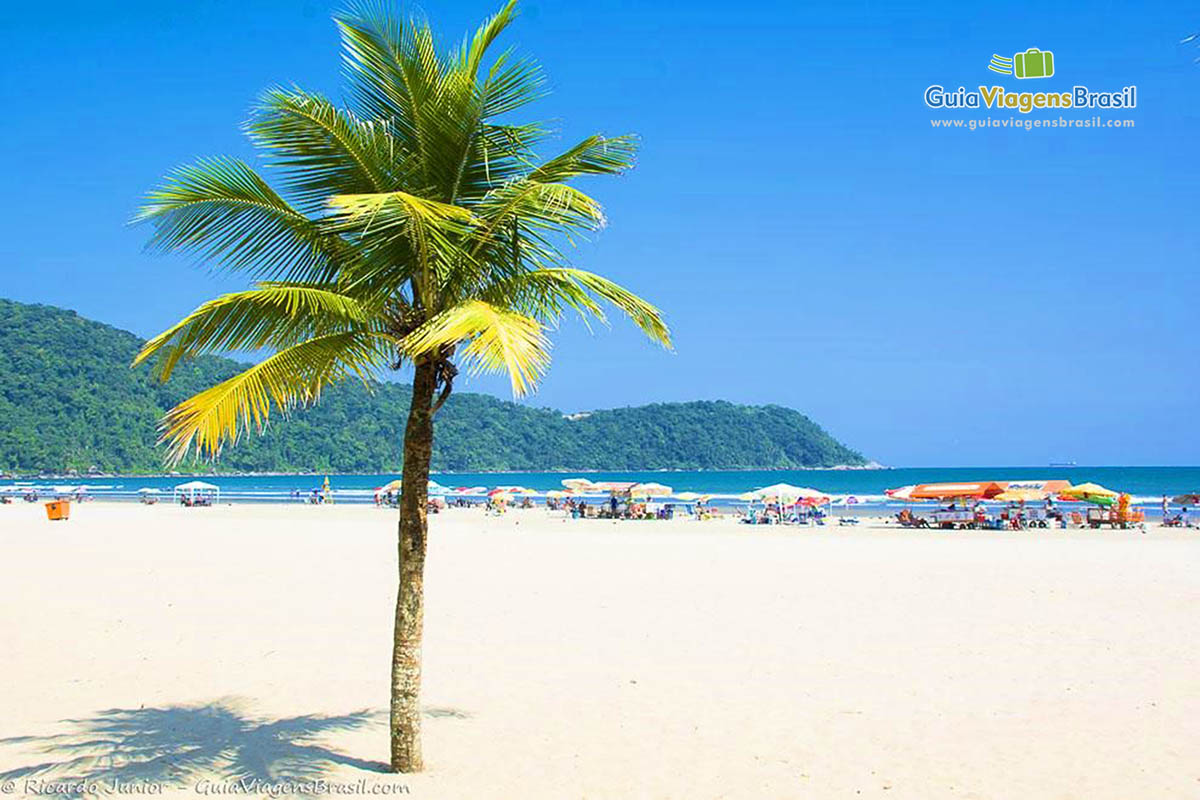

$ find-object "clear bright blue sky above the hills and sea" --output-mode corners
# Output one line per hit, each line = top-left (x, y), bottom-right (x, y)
(0, 0), (1200, 465)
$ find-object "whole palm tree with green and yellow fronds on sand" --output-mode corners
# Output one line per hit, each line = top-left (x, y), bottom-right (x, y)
(134, 0), (671, 772)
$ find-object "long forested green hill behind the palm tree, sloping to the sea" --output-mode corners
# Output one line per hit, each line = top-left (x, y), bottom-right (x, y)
(0, 300), (864, 474)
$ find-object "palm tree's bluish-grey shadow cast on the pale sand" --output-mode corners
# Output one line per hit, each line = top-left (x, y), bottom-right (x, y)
(0, 699), (468, 796)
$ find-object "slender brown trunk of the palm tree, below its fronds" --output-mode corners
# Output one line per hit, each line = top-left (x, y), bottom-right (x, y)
(391, 363), (436, 772)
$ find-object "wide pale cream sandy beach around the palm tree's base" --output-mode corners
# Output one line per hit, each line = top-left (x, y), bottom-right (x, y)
(0, 503), (1200, 800)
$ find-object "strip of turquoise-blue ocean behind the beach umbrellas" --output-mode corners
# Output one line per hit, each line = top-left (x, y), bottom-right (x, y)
(0, 467), (1200, 507)
